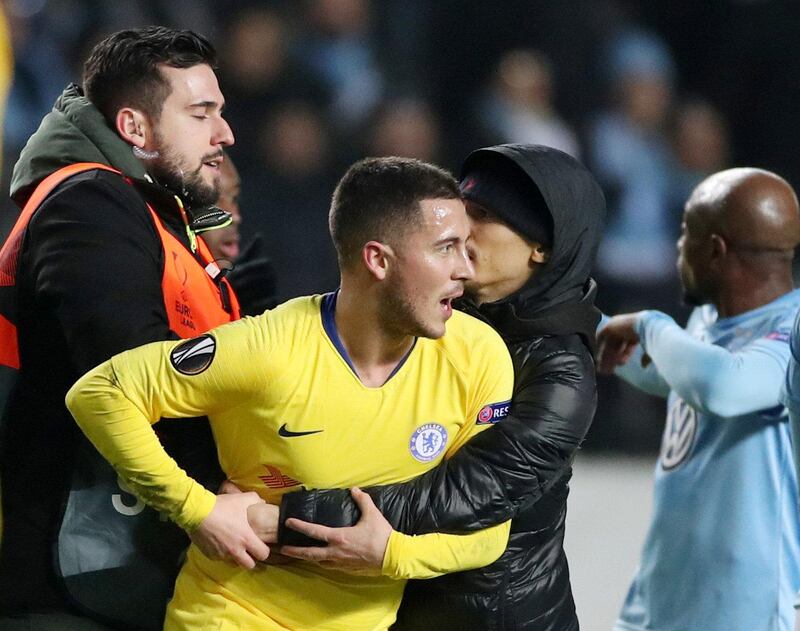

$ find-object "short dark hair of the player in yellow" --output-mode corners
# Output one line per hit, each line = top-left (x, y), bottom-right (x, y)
(328, 157), (461, 269)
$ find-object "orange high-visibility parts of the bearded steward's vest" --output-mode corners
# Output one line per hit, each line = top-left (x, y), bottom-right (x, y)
(0, 162), (240, 369)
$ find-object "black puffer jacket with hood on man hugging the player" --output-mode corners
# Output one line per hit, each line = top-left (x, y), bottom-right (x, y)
(281, 145), (605, 631)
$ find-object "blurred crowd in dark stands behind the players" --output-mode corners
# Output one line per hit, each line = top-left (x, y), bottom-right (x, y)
(0, 0), (800, 449)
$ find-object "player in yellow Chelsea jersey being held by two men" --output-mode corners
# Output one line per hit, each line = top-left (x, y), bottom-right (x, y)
(67, 158), (513, 631)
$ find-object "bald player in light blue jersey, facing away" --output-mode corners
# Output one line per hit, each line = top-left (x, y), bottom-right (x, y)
(599, 169), (800, 631)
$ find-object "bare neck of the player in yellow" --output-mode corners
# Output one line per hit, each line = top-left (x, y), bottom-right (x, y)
(334, 283), (414, 388)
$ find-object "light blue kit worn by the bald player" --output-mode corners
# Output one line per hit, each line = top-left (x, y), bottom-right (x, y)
(614, 290), (800, 631)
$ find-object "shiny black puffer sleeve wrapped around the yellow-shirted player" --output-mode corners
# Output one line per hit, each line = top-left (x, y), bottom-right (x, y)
(279, 353), (596, 545)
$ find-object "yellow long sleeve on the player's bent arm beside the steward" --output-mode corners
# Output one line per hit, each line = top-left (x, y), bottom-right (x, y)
(66, 322), (270, 532)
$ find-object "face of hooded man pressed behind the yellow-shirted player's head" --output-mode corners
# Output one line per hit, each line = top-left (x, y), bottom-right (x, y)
(466, 200), (547, 304)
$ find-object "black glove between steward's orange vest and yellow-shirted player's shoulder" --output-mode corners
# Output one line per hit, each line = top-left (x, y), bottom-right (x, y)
(226, 234), (278, 315)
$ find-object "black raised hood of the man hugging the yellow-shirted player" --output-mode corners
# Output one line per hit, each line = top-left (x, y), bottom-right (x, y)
(461, 144), (606, 356)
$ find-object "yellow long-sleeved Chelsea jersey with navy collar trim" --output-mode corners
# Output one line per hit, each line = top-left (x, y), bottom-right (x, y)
(68, 294), (513, 630)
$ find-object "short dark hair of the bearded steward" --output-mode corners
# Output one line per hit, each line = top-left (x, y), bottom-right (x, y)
(83, 26), (217, 126)
